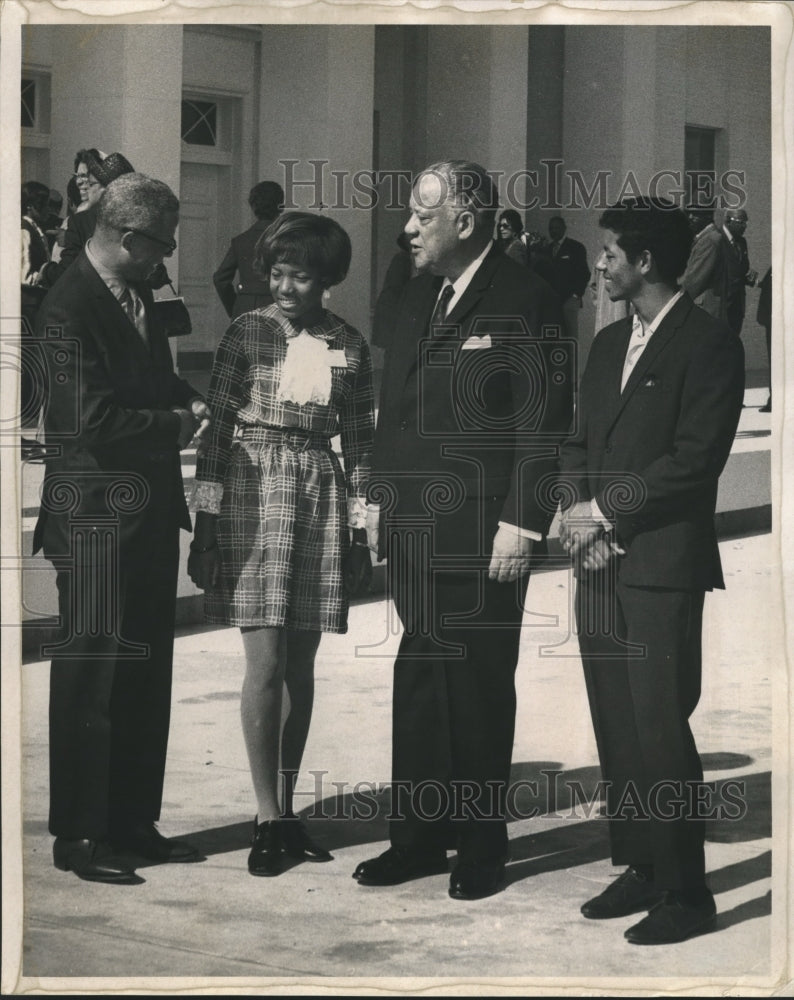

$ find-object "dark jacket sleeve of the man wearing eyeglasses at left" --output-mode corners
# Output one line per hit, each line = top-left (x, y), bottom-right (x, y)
(36, 301), (181, 448)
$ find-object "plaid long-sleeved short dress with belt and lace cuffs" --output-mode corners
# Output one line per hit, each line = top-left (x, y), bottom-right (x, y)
(194, 305), (374, 632)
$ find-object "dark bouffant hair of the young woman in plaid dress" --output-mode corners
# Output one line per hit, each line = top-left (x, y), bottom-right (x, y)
(256, 212), (353, 288)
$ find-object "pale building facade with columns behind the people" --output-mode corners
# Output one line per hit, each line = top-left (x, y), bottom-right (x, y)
(22, 24), (772, 376)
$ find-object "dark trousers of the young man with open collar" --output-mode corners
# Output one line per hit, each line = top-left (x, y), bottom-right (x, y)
(576, 569), (705, 889)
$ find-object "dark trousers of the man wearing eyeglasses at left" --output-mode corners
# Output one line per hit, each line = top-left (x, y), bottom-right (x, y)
(50, 523), (179, 840)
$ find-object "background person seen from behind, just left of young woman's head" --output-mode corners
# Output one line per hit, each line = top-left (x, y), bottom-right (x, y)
(212, 181), (284, 319)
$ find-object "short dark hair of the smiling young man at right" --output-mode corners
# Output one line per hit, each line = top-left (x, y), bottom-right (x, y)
(598, 198), (693, 284)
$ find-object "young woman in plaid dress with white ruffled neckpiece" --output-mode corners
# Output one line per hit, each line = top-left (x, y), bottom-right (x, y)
(188, 212), (374, 875)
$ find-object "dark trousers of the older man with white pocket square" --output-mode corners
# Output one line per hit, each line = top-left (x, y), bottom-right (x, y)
(389, 536), (528, 861)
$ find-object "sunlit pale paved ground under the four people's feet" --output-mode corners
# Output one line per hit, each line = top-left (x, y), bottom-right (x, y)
(6, 535), (792, 995)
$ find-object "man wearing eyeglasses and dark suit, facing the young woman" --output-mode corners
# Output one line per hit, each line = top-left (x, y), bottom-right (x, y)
(34, 173), (210, 885)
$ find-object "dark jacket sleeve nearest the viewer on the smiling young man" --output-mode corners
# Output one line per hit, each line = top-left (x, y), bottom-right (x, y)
(596, 330), (744, 537)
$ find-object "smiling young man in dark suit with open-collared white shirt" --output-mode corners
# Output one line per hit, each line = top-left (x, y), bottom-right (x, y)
(560, 199), (744, 944)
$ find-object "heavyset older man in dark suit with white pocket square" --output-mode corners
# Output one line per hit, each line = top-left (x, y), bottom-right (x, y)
(354, 161), (574, 899)
